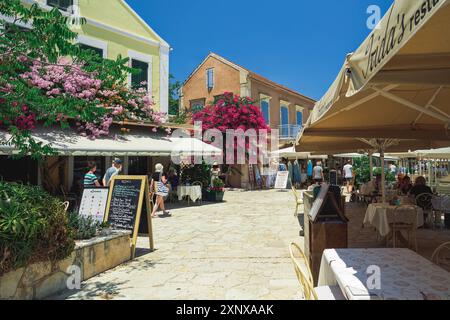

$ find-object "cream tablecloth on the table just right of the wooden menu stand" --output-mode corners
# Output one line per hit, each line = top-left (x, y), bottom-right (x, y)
(364, 203), (424, 237)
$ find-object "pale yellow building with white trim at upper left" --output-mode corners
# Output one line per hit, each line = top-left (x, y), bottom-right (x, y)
(7, 0), (170, 113)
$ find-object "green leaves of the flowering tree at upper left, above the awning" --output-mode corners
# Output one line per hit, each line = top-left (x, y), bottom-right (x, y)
(0, 0), (153, 159)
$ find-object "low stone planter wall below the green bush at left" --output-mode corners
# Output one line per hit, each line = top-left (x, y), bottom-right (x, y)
(0, 231), (131, 300)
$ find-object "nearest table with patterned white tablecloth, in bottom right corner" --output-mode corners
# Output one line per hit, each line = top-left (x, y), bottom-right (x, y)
(318, 249), (450, 300)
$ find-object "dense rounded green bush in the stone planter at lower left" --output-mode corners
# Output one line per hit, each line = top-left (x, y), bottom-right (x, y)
(0, 182), (75, 276)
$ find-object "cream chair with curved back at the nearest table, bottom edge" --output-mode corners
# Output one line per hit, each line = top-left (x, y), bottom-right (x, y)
(289, 243), (346, 300)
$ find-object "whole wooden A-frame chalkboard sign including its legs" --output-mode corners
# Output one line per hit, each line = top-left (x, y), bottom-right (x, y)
(105, 176), (154, 257)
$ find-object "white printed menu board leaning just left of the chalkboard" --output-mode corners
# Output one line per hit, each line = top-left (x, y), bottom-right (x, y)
(78, 188), (109, 224)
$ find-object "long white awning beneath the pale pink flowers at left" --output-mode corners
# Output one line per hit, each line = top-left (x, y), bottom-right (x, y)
(0, 128), (222, 156)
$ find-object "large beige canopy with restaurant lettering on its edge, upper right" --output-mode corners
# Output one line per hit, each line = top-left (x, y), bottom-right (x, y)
(297, 0), (450, 152)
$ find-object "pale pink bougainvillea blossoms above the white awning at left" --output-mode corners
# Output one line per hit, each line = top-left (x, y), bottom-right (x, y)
(16, 59), (167, 139)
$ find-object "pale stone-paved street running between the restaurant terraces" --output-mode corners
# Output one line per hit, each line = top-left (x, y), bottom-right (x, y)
(57, 191), (302, 300)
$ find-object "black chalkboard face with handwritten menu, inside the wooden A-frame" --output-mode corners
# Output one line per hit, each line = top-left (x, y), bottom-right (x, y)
(108, 180), (142, 231)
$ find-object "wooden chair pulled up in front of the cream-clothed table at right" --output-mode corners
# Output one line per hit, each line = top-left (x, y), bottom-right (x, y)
(391, 206), (419, 252)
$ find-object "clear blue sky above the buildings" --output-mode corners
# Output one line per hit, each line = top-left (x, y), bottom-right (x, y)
(127, 0), (392, 99)
